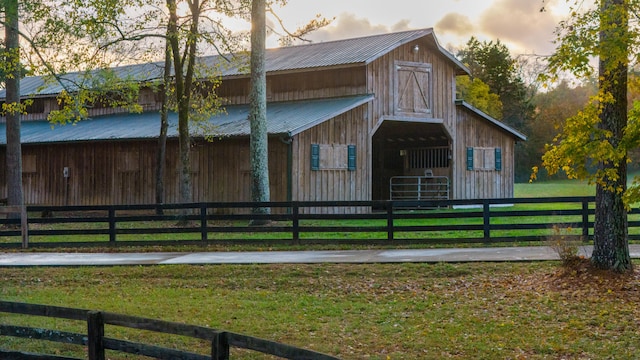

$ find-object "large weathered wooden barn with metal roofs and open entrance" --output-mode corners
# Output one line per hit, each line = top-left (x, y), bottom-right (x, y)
(0, 29), (526, 211)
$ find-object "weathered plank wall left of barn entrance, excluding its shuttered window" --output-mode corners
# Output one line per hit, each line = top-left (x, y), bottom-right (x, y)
(292, 106), (371, 212)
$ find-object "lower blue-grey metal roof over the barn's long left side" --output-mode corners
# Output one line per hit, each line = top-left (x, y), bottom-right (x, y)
(0, 95), (373, 145)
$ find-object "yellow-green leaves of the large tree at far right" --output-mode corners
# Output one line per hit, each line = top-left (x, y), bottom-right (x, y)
(541, 1), (640, 203)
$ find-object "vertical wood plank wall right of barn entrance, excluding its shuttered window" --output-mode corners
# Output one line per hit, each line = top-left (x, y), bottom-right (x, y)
(453, 108), (515, 199)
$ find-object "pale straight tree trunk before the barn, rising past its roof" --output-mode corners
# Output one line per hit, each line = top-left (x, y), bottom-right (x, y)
(249, 0), (270, 225)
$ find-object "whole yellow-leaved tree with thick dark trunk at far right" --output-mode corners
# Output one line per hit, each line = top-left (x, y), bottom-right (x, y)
(543, 0), (640, 272)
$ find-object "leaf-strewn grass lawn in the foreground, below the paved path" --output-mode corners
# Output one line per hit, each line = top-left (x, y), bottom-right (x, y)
(0, 262), (640, 359)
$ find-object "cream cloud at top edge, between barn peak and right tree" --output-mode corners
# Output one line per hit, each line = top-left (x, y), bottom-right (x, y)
(478, 0), (559, 54)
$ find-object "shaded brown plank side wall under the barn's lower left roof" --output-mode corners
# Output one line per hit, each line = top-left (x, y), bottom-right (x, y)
(0, 139), (287, 205)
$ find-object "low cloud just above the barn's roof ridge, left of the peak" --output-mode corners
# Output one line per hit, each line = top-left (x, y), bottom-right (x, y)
(307, 13), (411, 42)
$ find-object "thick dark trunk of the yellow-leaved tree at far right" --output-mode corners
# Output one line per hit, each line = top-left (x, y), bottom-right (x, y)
(591, 0), (632, 271)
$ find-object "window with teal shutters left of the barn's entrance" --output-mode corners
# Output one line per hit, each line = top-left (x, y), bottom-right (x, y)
(311, 144), (356, 171)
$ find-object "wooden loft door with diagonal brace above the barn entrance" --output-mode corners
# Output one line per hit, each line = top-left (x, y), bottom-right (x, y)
(394, 62), (432, 117)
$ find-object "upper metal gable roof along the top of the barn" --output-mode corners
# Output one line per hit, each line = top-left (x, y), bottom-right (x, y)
(0, 28), (469, 99)
